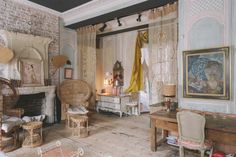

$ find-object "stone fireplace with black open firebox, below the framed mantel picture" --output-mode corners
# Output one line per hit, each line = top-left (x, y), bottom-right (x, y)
(17, 86), (56, 123)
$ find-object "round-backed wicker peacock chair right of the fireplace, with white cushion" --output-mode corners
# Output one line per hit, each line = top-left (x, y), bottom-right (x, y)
(59, 80), (92, 128)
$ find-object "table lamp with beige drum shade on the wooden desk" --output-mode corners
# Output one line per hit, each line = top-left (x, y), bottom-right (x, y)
(162, 84), (176, 111)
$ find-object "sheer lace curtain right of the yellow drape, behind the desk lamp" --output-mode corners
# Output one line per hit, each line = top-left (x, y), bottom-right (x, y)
(148, 3), (178, 104)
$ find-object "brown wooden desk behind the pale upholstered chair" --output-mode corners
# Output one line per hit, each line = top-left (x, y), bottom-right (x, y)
(150, 111), (236, 152)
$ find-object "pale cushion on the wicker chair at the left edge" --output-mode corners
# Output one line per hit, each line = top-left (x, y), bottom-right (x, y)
(2, 117), (24, 133)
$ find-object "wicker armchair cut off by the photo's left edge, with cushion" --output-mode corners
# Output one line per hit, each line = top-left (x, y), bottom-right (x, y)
(0, 77), (24, 152)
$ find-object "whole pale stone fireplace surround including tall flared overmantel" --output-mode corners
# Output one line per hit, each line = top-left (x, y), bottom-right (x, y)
(0, 30), (56, 123)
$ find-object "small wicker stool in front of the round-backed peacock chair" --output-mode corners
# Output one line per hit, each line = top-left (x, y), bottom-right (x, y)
(71, 115), (88, 137)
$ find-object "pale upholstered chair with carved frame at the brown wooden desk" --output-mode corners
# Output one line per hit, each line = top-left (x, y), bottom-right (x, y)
(176, 111), (212, 157)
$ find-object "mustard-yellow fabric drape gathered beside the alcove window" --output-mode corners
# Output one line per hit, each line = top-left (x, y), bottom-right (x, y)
(125, 31), (148, 92)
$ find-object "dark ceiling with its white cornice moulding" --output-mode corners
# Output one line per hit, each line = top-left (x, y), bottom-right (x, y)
(24, 0), (177, 29)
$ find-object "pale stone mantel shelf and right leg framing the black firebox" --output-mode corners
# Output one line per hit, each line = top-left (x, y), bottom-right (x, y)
(17, 86), (56, 123)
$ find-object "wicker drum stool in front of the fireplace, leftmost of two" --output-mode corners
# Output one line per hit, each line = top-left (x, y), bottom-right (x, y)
(22, 122), (43, 148)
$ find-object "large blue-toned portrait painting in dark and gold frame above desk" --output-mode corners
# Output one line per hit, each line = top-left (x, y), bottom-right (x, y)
(183, 47), (231, 100)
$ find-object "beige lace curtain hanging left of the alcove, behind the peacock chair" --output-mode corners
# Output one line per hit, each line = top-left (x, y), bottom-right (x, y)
(77, 26), (96, 105)
